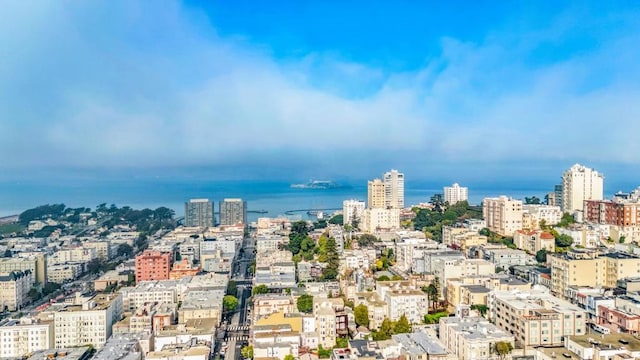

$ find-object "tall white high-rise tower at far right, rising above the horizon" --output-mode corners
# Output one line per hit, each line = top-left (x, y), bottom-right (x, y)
(562, 164), (604, 213)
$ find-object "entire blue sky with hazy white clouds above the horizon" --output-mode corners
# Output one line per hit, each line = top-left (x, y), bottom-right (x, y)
(0, 1), (640, 183)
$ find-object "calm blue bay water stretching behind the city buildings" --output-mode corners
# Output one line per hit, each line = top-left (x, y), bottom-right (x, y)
(0, 179), (552, 220)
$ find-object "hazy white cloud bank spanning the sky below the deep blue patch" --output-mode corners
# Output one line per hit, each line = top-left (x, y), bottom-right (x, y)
(0, 1), (640, 180)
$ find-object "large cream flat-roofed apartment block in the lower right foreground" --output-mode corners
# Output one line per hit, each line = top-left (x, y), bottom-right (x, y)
(488, 290), (587, 347)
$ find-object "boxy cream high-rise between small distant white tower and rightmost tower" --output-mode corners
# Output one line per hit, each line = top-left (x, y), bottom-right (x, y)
(482, 196), (522, 236)
